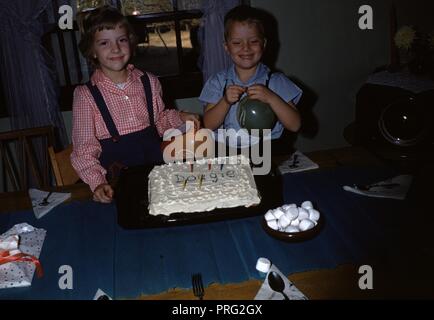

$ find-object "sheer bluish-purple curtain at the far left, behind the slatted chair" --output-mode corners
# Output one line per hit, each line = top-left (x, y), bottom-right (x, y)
(0, 0), (67, 146)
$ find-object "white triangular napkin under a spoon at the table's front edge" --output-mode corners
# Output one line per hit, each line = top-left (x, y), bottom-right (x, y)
(255, 264), (308, 300)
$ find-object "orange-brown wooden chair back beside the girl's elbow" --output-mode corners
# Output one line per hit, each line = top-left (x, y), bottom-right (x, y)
(48, 144), (80, 187)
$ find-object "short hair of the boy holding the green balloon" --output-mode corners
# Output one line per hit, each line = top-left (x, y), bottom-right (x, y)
(224, 5), (265, 41)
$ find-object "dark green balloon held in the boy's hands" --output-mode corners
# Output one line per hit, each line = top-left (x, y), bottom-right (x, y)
(237, 96), (277, 130)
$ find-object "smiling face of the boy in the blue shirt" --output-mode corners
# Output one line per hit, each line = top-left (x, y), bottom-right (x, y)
(225, 21), (265, 80)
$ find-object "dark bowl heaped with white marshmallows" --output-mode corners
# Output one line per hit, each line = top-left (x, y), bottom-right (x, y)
(262, 201), (324, 241)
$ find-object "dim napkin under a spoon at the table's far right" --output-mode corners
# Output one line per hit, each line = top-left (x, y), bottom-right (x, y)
(343, 175), (413, 200)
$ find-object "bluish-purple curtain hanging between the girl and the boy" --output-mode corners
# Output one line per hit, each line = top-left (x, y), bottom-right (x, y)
(198, 0), (242, 82)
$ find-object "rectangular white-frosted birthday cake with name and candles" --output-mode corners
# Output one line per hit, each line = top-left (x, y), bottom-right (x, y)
(148, 155), (261, 216)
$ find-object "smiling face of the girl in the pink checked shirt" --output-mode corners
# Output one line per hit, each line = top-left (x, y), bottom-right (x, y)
(94, 25), (131, 82)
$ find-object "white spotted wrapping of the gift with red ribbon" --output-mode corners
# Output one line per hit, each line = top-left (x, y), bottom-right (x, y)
(0, 223), (46, 289)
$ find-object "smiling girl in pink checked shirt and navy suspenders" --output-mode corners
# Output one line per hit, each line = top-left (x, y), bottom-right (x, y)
(71, 6), (199, 203)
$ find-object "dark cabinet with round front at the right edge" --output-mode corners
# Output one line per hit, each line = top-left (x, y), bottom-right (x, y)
(354, 83), (434, 159)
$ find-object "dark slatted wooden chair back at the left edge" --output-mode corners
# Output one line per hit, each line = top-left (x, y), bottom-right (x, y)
(0, 126), (54, 191)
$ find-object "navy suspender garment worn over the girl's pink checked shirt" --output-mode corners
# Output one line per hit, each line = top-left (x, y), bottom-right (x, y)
(86, 73), (163, 179)
